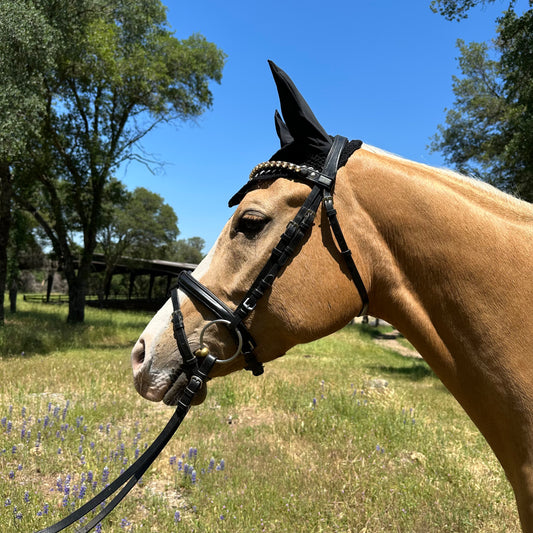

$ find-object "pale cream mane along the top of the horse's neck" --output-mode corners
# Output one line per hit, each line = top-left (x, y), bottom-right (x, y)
(361, 143), (533, 224)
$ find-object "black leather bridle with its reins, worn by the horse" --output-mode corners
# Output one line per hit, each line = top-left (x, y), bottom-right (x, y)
(37, 136), (368, 533)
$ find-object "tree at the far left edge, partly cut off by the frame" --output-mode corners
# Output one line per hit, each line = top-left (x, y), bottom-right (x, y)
(0, 0), (57, 325)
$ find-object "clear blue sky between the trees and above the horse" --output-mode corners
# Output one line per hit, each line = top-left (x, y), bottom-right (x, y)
(118, 0), (527, 252)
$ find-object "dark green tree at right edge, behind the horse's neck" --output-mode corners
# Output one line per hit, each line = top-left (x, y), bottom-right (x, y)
(431, 2), (533, 202)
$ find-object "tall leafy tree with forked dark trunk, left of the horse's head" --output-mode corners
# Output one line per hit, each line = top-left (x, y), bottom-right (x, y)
(8, 0), (225, 322)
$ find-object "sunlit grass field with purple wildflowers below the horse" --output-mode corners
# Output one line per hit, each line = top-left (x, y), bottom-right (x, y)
(0, 302), (519, 533)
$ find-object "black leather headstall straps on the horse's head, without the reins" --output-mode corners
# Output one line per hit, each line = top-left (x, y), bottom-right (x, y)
(171, 136), (369, 376)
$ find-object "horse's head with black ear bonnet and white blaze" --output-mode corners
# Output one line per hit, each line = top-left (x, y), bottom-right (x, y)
(132, 62), (370, 405)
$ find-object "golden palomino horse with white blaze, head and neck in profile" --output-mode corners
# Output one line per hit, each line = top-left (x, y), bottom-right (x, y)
(132, 64), (533, 532)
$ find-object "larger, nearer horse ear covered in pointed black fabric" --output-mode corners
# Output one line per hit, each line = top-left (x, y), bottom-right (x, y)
(268, 61), (331, 146)
